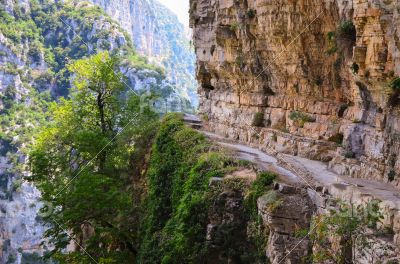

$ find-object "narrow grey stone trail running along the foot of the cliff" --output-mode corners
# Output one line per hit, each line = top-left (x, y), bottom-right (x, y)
(184, 115), (400, 213)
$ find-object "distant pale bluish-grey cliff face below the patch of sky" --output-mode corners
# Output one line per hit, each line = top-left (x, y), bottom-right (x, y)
(91, 0), (198, 106)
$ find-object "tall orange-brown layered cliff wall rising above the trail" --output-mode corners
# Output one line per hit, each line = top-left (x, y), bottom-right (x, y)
(190, 0), (400, 187)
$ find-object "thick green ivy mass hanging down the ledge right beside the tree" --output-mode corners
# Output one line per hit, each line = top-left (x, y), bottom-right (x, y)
(138, 114), (253, 263)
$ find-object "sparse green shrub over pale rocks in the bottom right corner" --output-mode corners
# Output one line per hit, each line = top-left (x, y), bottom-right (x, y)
(304, 200), (390, 263)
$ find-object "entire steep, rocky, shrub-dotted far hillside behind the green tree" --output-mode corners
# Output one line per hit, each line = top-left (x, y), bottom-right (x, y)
(0, 0), (182, 263)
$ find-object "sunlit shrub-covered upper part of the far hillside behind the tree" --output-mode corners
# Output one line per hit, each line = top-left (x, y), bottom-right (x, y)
(0, 0), (173, 180)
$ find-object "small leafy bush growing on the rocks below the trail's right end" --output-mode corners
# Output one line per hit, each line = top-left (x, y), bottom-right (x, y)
(310, 200), (384, 263)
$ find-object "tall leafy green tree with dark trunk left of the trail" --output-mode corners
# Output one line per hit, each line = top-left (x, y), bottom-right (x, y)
(30, 52), (157, 263)
